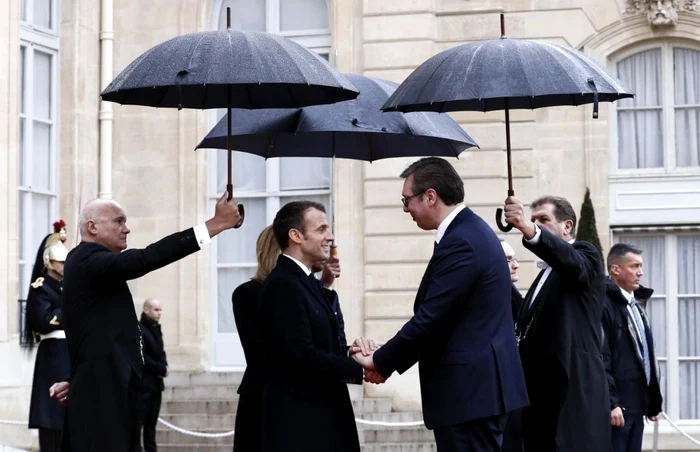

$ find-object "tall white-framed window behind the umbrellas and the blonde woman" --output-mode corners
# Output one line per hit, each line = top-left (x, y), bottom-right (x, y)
(207, 0), (332, 368)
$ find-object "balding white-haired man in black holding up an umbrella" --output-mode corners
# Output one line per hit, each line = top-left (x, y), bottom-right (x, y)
(52, 193), (241, 452)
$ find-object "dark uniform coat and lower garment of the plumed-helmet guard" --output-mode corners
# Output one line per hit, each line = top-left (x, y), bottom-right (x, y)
(27, 276), (70, 430)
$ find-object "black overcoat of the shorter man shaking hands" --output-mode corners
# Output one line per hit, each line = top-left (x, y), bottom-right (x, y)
(259, 255), (363, 452)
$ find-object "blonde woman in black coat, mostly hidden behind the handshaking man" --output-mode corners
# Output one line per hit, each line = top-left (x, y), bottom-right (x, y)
(231, 226), (280, 452)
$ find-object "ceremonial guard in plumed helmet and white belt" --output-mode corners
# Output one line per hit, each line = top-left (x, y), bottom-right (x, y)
(25, 220), (70, 452)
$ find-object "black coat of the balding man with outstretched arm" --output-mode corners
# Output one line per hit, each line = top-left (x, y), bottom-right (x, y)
(63, 229), (199, 452)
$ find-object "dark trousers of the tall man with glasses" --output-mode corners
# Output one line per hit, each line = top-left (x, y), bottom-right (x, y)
(433, 414), (508, 452)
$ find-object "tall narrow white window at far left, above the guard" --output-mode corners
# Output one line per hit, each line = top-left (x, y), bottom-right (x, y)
(18, 0), (59, 298)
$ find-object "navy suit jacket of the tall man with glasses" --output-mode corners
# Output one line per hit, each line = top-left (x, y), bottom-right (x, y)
(374, 208), (527, 429)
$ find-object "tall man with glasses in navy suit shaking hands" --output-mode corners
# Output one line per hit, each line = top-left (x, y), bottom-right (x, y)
(354, 157), (527, 452)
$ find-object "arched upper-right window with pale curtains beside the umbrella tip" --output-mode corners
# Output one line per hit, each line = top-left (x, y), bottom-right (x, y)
(617, 43), (700, 172)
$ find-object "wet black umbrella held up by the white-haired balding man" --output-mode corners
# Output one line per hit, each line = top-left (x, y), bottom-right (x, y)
(102, 8), (358, 226)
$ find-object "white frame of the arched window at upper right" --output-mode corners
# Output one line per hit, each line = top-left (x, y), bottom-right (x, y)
(608, 39), (700, 180)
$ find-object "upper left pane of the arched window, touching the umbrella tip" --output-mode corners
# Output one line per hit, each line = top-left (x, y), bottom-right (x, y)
(617, 49), (661, 108)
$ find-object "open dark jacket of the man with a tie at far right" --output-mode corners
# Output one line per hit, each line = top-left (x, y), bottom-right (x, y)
(603, 279), (662, 416)
